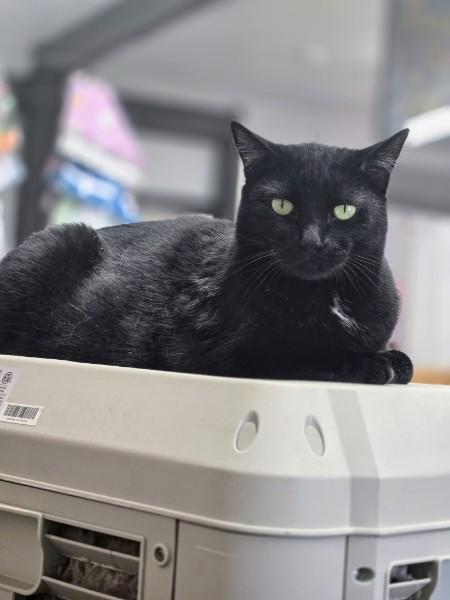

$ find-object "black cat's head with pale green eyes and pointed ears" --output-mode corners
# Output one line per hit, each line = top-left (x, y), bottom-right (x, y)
(231, 122), (408, 280)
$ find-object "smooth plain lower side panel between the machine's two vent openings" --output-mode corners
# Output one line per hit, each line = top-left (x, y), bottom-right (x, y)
(175, 523), (345, 600)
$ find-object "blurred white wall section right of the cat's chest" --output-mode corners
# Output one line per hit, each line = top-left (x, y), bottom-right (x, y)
(387, 208), (450, 369)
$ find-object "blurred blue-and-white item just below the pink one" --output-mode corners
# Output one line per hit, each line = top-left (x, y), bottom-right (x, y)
(47, 160), (138, 223)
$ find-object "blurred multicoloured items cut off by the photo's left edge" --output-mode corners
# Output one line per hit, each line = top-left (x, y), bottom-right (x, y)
(0, 77), (25, 193)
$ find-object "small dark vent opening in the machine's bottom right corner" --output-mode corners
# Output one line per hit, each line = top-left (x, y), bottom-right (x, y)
(387, 561), (438, 600)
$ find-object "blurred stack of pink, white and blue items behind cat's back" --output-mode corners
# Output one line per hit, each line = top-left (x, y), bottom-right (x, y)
(47, 72), (143, 222)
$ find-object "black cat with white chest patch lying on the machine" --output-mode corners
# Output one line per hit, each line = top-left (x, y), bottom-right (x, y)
(0, 123), (412, 383)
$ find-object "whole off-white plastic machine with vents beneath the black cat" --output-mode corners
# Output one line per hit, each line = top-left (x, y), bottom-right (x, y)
(0, 356), (450, 600)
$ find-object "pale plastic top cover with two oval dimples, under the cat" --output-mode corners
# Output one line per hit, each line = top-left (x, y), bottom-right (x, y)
(0, 357), (450, 537)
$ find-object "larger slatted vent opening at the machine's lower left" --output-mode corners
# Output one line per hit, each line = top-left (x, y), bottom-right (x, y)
(33, 521), (141, 600)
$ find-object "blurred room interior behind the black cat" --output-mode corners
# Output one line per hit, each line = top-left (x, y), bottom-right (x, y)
(0, 0), (450, 383)
